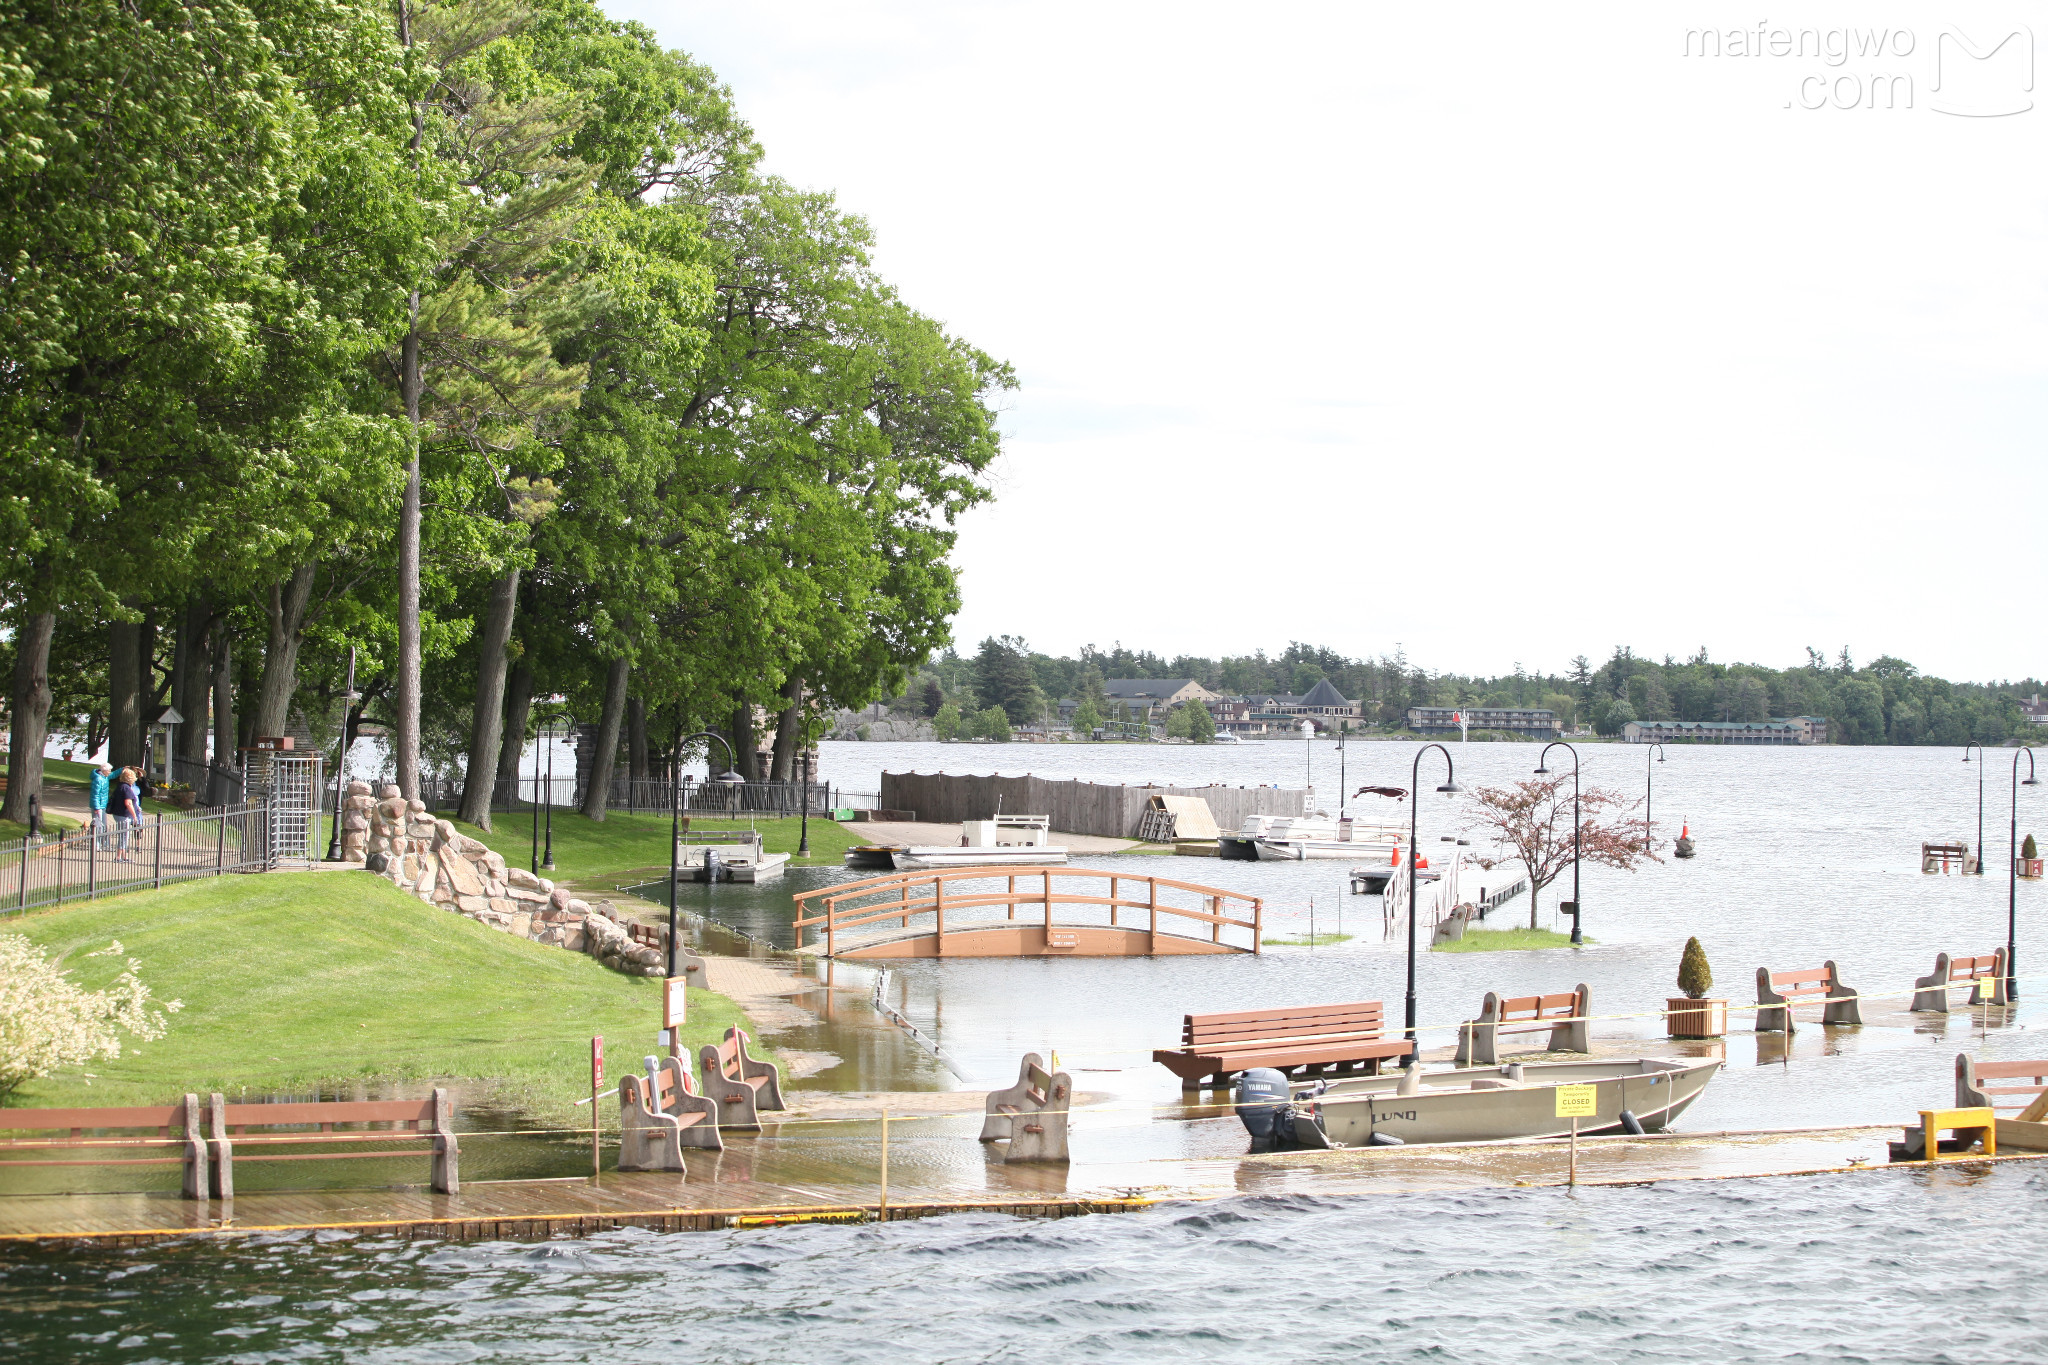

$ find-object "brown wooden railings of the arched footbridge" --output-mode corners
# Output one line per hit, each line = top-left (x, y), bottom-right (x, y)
(795, 868), (1266, 958)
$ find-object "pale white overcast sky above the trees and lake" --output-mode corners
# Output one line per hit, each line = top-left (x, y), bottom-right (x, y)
(606, 0), (2048, 679)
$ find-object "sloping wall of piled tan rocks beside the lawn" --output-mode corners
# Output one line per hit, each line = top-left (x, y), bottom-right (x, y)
(342, 782), (664, 976)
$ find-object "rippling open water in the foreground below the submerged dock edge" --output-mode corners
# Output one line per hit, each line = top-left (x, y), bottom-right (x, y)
(0, 1166), (2048, 1365)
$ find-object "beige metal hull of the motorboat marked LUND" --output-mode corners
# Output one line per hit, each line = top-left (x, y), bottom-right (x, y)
(1292, 1056), (1720, 1148)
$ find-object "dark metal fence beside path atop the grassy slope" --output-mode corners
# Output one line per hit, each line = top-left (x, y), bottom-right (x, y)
(0, 800), (290, 915)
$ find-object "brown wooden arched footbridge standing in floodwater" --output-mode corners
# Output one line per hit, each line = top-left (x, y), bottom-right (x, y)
(795, 866), (1264, 960)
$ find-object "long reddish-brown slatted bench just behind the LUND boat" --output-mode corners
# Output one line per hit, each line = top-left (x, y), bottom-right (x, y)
(1153, 1001), (1411, 1091)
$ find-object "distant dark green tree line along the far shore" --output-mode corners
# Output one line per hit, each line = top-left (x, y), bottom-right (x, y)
(893, 634), (2042, 747)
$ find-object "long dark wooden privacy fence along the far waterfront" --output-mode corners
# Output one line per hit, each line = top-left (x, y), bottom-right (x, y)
(881, 774), (1309, 839)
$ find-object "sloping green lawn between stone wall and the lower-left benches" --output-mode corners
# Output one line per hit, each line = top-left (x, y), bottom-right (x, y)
(0, 872), (752, 1126)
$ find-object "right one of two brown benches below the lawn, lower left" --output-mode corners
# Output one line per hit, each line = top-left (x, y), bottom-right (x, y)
(209, 1087), (463, 1199)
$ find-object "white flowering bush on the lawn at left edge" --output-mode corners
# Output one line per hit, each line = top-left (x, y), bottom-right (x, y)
(0, 933), (184, 1095)
